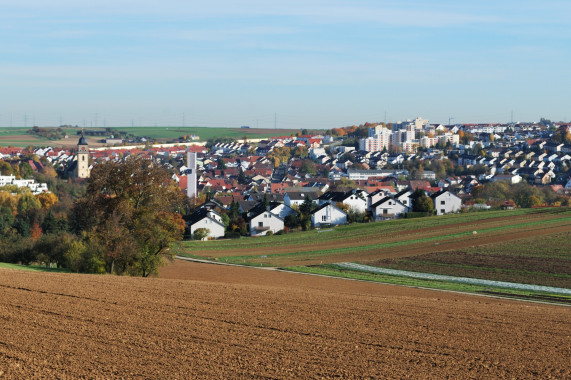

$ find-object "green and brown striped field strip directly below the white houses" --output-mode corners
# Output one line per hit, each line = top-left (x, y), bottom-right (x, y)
(181, 208), (571, 267)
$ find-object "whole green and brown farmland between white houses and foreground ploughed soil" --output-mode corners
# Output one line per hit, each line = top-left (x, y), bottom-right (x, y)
(181, 208), (571, 303)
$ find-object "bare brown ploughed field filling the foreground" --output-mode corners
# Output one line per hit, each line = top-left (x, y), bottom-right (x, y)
(0, 262), (571, 379)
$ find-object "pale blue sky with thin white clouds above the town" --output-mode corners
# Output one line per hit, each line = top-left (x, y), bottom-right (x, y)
(0, 0), (571, 128)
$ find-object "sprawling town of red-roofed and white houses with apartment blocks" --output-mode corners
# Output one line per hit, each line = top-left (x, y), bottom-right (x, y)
(0, 117), (571, 239)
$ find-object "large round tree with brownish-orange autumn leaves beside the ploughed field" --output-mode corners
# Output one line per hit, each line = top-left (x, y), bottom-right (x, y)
(72, 157), (185, 277)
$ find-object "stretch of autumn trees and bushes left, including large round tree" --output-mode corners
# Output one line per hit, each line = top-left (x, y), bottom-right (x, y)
(0, 157), (185, 277)
